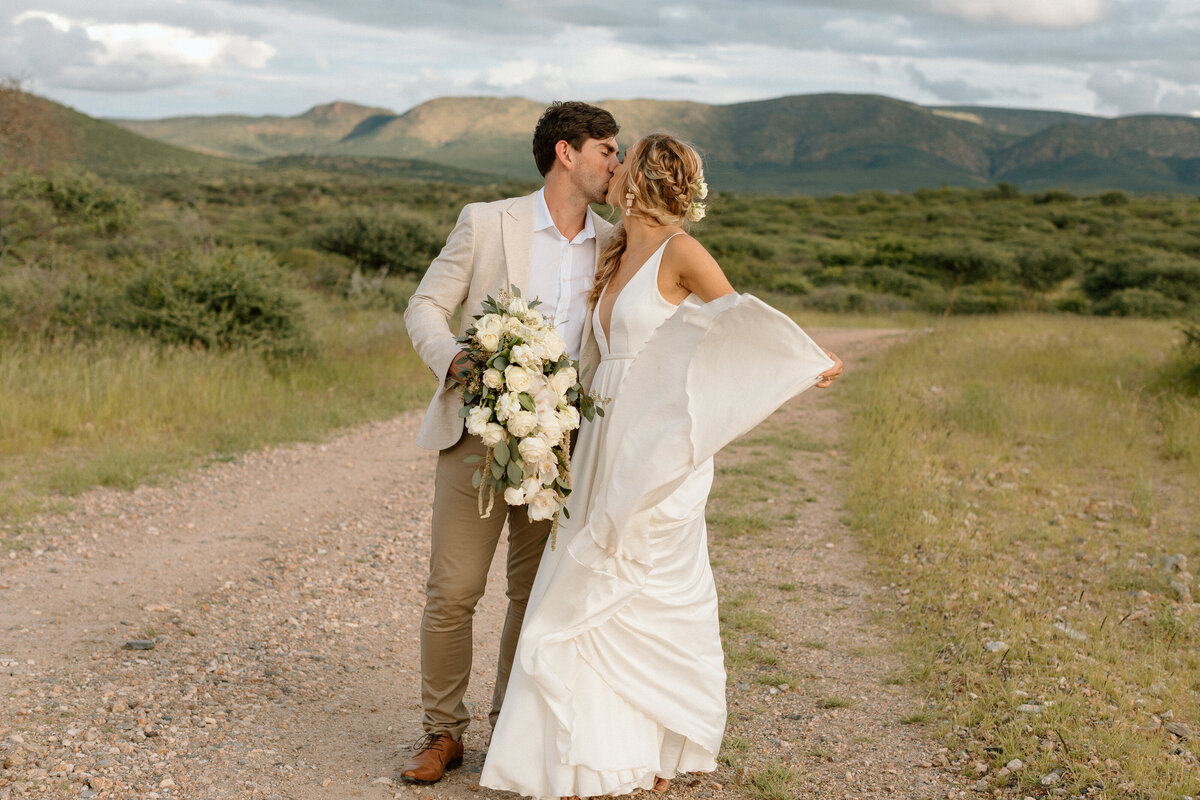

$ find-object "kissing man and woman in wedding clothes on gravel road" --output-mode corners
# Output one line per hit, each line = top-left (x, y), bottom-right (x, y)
(401, 102), (841, 798)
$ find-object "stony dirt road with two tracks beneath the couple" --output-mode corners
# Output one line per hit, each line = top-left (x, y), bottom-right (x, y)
(0, 330), (959, 800)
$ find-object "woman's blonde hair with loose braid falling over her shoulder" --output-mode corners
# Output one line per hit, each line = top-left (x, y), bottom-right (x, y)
(588, 133), (703, 306)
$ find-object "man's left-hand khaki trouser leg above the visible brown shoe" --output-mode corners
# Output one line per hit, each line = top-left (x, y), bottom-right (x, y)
(421, 435), (508, 739)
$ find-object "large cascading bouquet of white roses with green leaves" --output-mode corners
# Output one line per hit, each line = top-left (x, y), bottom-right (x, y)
(458, 287), (604, 547)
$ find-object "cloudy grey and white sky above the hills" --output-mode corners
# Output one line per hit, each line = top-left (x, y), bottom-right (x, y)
(0, 0), (1200, 118)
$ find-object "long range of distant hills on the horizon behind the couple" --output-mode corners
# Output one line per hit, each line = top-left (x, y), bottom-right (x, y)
(105, 94), (1200, 194)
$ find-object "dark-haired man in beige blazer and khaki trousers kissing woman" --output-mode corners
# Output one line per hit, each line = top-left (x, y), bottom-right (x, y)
(401, 102), (619, 783)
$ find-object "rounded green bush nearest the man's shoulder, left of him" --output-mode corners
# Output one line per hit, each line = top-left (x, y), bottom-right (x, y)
(316, 209), (444, 276)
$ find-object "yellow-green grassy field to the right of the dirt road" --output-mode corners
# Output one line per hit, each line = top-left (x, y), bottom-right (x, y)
(846, 317), (1200, 799)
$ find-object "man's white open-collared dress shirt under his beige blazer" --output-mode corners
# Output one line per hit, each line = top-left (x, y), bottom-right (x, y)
(526, 188), (596, 359)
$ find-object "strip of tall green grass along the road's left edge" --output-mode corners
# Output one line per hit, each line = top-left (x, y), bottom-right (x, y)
(0, 303), (432, 532)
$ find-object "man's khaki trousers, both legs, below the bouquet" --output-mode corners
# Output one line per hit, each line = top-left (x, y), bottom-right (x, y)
(421, 433), (550, 739)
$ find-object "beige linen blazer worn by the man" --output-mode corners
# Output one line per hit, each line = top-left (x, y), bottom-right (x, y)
(404, 194), (612, 450)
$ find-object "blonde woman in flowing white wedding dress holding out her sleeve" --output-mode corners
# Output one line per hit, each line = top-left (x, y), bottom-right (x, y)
(480, 134), (841, 798)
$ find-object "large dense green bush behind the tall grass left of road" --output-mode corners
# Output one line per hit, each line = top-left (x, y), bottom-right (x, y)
(113, 248), (311, 357)
